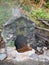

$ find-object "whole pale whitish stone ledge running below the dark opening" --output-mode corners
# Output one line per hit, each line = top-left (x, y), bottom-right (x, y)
(7, 47), (49, 62)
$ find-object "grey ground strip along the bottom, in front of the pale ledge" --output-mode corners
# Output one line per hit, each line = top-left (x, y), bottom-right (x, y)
(0, 60), (49, 65)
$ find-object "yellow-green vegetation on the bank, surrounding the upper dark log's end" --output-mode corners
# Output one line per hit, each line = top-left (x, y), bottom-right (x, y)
(27, 8), (49, 29)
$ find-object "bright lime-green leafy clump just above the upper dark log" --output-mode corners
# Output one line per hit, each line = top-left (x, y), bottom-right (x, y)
(31, 9), (49, 19)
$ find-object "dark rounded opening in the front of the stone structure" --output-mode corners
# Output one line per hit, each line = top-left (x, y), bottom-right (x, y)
(15, 35), (27, 49)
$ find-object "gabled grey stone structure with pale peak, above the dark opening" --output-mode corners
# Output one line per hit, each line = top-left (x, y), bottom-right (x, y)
(2, 8), (35, 43)
